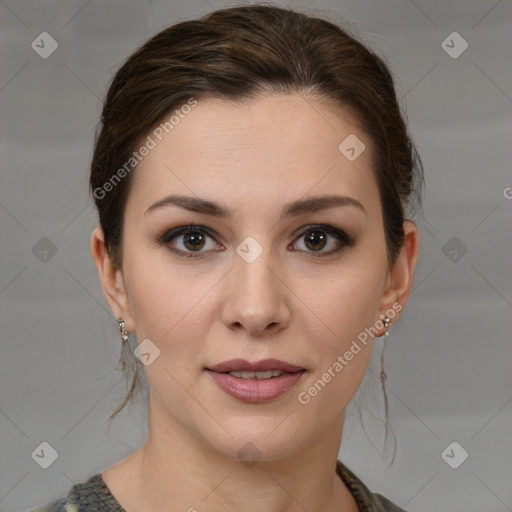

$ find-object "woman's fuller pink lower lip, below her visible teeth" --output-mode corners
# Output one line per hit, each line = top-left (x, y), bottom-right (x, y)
(206, 370), (305, 404)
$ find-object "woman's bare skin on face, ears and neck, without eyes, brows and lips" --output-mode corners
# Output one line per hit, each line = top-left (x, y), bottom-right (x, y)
(91, 94), (419, 512)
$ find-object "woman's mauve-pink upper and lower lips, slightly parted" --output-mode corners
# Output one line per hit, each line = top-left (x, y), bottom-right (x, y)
(205, 359), (306, 404)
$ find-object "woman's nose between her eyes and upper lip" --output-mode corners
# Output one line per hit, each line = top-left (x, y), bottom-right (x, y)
(222, 249), (291, 336)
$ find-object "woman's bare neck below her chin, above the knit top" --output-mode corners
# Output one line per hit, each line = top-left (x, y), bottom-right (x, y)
(104, 394), (358, 512)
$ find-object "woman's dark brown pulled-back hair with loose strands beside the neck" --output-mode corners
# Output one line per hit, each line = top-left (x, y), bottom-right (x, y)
(90, 4), (423, 460)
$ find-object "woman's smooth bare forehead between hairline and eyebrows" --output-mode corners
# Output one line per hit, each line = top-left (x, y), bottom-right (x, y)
(128, 94), (378, 216)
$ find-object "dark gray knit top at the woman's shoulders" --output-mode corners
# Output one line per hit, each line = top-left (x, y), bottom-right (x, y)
(31, 460), (406, 512)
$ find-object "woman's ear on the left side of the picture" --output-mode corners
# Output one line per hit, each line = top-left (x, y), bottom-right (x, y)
(91, 225), (135, 332)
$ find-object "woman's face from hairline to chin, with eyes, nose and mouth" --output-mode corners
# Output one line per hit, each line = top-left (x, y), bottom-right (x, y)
(92, 94), (410, 460)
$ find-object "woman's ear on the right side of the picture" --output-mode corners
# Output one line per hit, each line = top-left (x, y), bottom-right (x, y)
(380, 220), (419, 323)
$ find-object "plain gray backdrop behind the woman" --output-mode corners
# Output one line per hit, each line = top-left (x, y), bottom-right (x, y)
(0, 0), (512, 512)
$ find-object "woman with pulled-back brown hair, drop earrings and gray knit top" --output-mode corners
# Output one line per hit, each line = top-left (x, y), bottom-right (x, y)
(34, 5), (422, 512)
